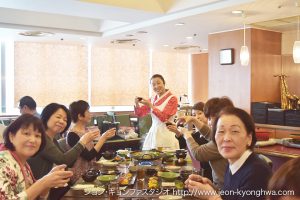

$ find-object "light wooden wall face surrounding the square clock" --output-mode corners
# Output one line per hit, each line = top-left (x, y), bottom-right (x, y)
(208, 29), (251, 111)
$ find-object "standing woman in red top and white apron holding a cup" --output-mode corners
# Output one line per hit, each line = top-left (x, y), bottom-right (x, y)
(134, 74), (179, 150)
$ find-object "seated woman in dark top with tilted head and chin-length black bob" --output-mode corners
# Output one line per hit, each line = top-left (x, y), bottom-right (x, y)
(28, 103), (98, 179)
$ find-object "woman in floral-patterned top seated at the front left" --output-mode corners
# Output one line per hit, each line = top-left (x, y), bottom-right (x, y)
(0, 114), (73, 200)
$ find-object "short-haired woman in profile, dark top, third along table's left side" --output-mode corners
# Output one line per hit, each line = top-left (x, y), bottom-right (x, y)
(67, 100), (116, 182)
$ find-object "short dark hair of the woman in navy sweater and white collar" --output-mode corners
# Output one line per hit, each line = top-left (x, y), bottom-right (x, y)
(212, 106), (257, 149)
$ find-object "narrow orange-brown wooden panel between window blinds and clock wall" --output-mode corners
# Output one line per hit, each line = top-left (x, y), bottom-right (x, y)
(191, 53), (208, 103)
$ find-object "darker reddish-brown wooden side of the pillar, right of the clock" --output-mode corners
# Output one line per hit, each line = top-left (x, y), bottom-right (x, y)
(251, 29), (281, 102)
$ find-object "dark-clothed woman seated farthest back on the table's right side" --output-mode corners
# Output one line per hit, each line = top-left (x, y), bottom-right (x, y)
(168, 102), (213, 180)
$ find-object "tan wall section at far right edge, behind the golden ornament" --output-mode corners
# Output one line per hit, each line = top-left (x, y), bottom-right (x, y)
(282, 55), (300, 97)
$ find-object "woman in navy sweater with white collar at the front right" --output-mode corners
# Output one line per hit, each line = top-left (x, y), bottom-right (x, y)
(185, 107), (271, 200)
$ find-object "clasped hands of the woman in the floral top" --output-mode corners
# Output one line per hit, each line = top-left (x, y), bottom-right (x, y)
(41, 165), (73, 188)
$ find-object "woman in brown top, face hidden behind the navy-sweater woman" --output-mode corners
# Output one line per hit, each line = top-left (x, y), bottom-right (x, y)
(169, 97), (234, 189)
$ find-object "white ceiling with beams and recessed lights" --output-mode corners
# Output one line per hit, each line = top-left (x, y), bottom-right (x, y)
(0, 0), (300, 52)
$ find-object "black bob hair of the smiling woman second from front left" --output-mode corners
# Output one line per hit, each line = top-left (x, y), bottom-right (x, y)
(41, 103), (71, 134)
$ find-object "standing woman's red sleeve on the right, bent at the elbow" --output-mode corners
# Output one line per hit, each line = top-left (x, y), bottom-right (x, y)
(152, 96), (178, 122)
